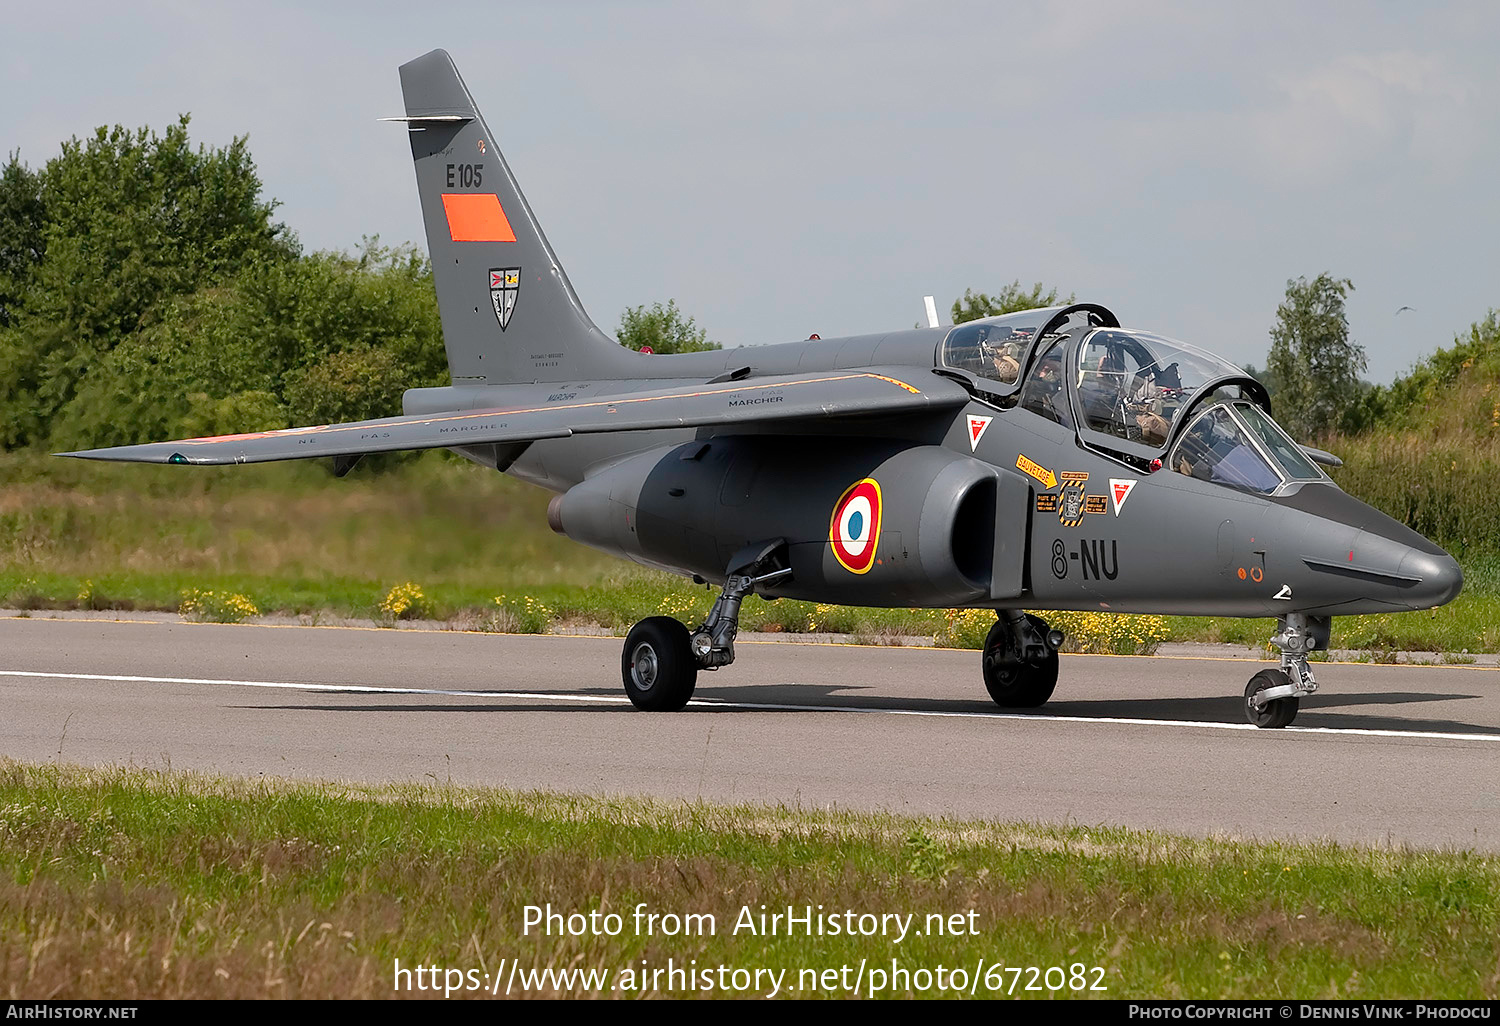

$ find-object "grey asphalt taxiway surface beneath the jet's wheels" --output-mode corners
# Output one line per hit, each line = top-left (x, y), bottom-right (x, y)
(0, 618), (1500, 851)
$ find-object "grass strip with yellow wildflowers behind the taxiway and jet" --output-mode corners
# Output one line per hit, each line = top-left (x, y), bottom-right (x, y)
(0, 453), (1500, 654)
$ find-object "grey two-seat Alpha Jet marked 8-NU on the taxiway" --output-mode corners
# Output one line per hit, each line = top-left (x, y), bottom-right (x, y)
(68, 50), (1463, 728)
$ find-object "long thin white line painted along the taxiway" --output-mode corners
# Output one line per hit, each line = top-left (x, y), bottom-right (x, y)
(0, 671), (1500, 743)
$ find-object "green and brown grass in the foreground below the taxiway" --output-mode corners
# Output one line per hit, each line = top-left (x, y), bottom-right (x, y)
(0, 762), (1500, 999)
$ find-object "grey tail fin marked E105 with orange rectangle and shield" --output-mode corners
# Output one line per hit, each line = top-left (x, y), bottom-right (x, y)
(390, 50), (636, 386)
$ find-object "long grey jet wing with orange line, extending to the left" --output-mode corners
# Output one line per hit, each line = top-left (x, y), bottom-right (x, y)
(59, 368), (969, 465)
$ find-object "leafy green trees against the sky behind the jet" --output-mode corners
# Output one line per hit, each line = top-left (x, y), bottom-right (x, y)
(0, 116), (1494, 449)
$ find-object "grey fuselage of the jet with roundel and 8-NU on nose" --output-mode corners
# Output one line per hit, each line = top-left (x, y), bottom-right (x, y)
(405, 312), (1463, 617)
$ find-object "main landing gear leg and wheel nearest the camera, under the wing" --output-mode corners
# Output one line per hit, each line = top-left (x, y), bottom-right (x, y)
(620, 539), (792, 713)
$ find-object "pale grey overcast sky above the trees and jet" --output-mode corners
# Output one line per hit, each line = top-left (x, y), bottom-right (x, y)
(0, 0), (1500, 381)
